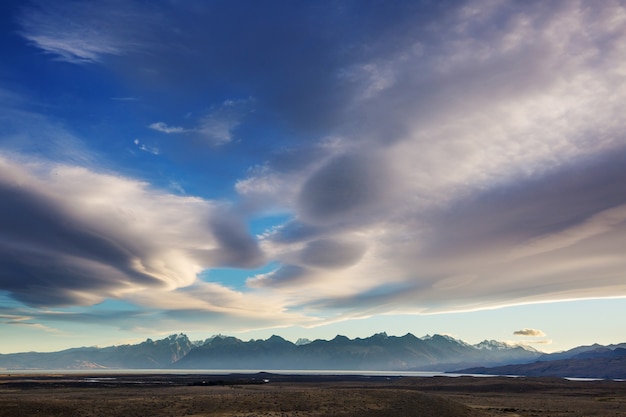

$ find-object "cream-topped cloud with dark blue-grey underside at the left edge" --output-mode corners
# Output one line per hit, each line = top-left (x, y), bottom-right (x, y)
(0, 157), (260, 306)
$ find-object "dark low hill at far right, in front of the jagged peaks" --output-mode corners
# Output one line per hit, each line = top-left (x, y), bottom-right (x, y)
(459, 344), (626, 379)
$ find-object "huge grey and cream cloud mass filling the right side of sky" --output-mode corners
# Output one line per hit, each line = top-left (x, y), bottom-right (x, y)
(237, 1), (626, 317)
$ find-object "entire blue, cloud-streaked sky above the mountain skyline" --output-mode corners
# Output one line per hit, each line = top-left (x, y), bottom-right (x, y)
(0, 0), (626, 353)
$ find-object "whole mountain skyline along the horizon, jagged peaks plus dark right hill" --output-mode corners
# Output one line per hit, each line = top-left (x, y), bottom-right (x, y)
(0, 333), (626, 379)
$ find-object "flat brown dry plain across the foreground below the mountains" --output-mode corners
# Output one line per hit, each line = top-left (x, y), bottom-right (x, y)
(0, 374), (626, 417)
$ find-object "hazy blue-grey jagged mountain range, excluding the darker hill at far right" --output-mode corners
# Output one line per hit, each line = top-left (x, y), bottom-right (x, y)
(0, 333), (541, 371)
